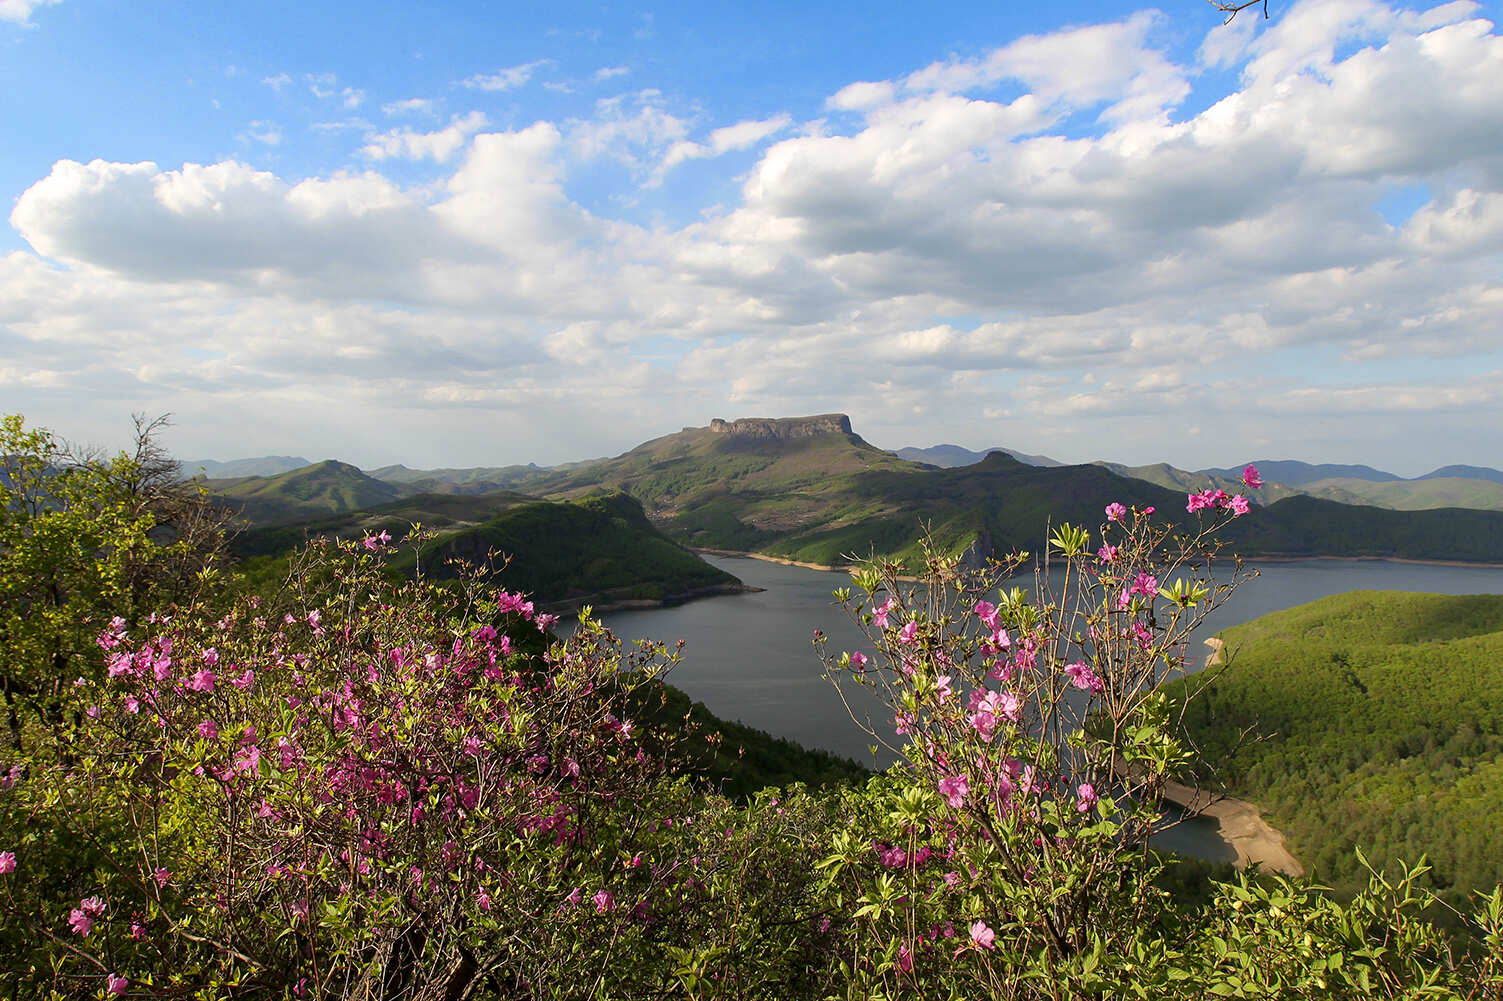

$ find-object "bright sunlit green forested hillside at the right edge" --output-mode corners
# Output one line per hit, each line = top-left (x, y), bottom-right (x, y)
(1169, 591), (1503, 905)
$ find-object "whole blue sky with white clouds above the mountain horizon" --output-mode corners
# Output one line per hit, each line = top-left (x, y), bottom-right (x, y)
(0, 0), (1503, 475)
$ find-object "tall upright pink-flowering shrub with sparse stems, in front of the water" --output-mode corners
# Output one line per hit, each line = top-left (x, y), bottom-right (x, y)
(821, 470), (1255, 996)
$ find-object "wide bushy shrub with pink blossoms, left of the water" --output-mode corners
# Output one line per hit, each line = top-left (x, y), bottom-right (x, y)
(3, 538), (841, 998)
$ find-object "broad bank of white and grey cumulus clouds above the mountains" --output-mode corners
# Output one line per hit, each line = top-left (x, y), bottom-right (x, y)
(0, 0), (1503, 472)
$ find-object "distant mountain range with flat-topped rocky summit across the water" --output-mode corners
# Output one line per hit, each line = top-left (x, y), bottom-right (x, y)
(193, 415), (1503, 564)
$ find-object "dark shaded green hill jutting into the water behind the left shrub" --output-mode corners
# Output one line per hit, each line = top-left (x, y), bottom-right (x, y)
(234, 491), (739, 609)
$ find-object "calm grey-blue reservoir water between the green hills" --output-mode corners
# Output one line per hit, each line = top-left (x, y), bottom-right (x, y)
(580, 556), (1503, 858)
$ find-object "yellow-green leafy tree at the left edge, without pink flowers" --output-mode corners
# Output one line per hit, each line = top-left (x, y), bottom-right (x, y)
(0, 415), (227, 750)
